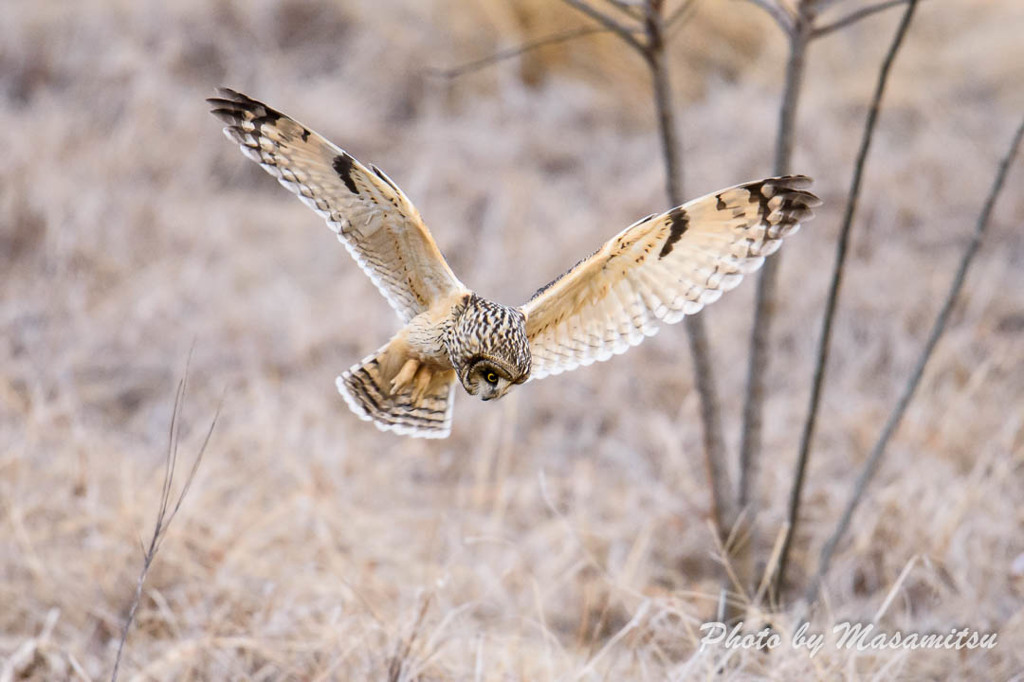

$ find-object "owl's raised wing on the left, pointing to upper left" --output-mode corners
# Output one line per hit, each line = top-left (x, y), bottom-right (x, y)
(207, 88), (466, 322)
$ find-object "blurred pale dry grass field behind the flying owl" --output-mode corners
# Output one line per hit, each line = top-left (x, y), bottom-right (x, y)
(0, 0), (1024, 680)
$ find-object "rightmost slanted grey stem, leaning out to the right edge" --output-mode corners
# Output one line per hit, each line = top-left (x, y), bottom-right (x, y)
(806, 115), (1024, 602)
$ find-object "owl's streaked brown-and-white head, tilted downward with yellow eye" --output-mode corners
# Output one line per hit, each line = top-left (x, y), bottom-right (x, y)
(447, 294), (530, 400)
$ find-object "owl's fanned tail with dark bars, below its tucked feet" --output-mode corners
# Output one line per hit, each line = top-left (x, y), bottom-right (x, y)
(337, 342), (456, 438)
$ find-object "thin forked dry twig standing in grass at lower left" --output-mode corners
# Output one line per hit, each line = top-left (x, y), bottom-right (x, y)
(111, 360), (220, 682)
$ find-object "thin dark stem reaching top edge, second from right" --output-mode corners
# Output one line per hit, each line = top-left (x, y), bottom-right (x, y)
(775, 0), (919, 594)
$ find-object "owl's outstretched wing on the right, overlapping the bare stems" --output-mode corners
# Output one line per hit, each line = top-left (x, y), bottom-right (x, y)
(521, 175), (820, 379)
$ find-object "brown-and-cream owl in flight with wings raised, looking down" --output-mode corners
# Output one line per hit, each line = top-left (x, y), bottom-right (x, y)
(207, 89), (820, 438)
